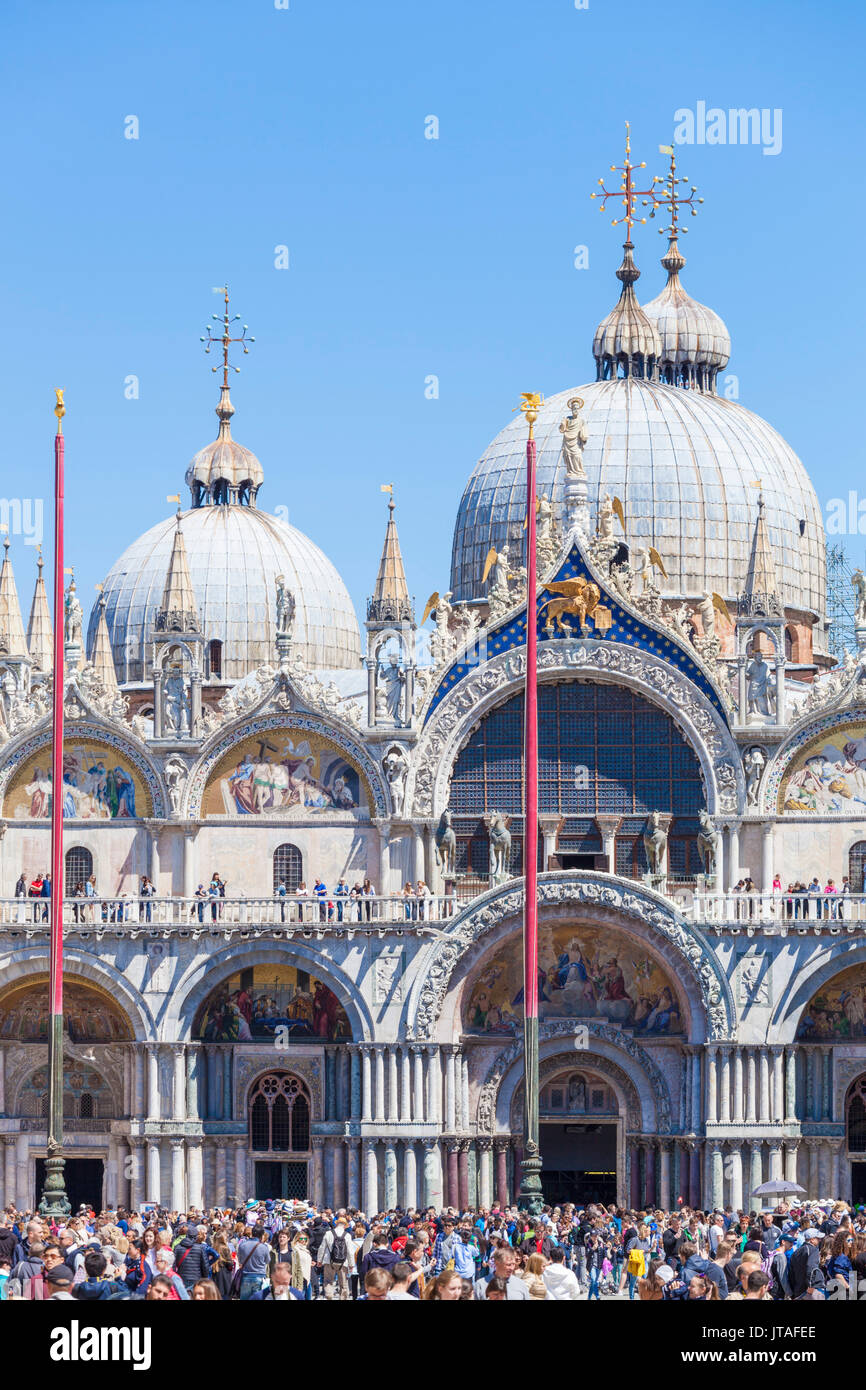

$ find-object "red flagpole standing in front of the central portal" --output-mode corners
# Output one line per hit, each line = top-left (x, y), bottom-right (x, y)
(517, 395), (542, 1216)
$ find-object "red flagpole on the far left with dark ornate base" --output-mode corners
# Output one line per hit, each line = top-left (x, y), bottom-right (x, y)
(39, 391), (70, 1216)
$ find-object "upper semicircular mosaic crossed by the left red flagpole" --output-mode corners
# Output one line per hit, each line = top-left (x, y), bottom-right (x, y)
(4, 738), (150, 820)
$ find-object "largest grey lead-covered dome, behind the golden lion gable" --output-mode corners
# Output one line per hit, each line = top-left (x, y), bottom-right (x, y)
(450, 375), (826, 617)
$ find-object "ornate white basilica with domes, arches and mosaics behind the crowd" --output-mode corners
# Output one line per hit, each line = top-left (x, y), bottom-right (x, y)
(0, 211), (866, 1212)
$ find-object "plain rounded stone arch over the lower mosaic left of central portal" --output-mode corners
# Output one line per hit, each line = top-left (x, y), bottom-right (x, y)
(160, 941), (374, 1043)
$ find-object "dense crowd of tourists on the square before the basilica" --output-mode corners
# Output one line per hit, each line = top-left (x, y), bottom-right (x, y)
(0, 1200), (866, 1302)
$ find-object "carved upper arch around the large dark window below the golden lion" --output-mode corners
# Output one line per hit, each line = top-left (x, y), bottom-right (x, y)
(406, 638), (745, 817)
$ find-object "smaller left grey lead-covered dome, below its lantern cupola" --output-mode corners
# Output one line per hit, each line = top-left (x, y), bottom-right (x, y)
(89, 506), (361, 682)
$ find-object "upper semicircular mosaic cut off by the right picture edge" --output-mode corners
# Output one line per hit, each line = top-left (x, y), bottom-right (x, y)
(778, 724), (866, 816)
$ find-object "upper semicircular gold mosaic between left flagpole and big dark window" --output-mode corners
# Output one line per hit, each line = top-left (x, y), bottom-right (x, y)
(203, 728), (368, 817)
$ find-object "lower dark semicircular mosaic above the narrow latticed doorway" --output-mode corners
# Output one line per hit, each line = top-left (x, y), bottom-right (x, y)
(193, 965), (352, 1043)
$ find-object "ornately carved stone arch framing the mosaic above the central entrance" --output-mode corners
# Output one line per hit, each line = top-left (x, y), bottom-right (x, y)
(413, 872), (735, 1040)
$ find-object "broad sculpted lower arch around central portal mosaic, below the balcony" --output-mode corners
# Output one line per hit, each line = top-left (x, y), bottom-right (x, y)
(403, 870), (737, 1043)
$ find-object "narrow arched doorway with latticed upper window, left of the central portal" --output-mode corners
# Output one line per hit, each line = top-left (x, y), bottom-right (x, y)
(249, 1072), (311, 1200)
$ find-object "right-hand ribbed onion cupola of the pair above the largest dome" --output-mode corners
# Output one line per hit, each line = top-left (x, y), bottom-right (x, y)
(644, 238), (731, 391)
